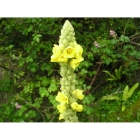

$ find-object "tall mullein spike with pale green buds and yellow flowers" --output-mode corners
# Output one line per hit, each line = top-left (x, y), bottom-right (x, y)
(51, 20), (84, 122)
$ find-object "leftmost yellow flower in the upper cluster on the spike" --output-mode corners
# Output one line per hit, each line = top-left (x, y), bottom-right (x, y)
(51, 44), (62, 62)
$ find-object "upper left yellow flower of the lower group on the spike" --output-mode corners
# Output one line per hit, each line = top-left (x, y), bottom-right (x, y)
(55, 92), (68, 104)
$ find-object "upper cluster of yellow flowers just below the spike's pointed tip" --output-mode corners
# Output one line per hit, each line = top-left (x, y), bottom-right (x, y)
(51, 41), (84, 69)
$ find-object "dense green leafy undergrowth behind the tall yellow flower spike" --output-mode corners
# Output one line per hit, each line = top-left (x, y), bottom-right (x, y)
(0, 18), (140, 122)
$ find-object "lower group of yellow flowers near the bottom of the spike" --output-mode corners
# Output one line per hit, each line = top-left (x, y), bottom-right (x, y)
(55, 89), (84, 120)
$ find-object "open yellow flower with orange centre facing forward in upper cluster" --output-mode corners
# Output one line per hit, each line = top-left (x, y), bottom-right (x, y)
(63, 47), (75, 58)
